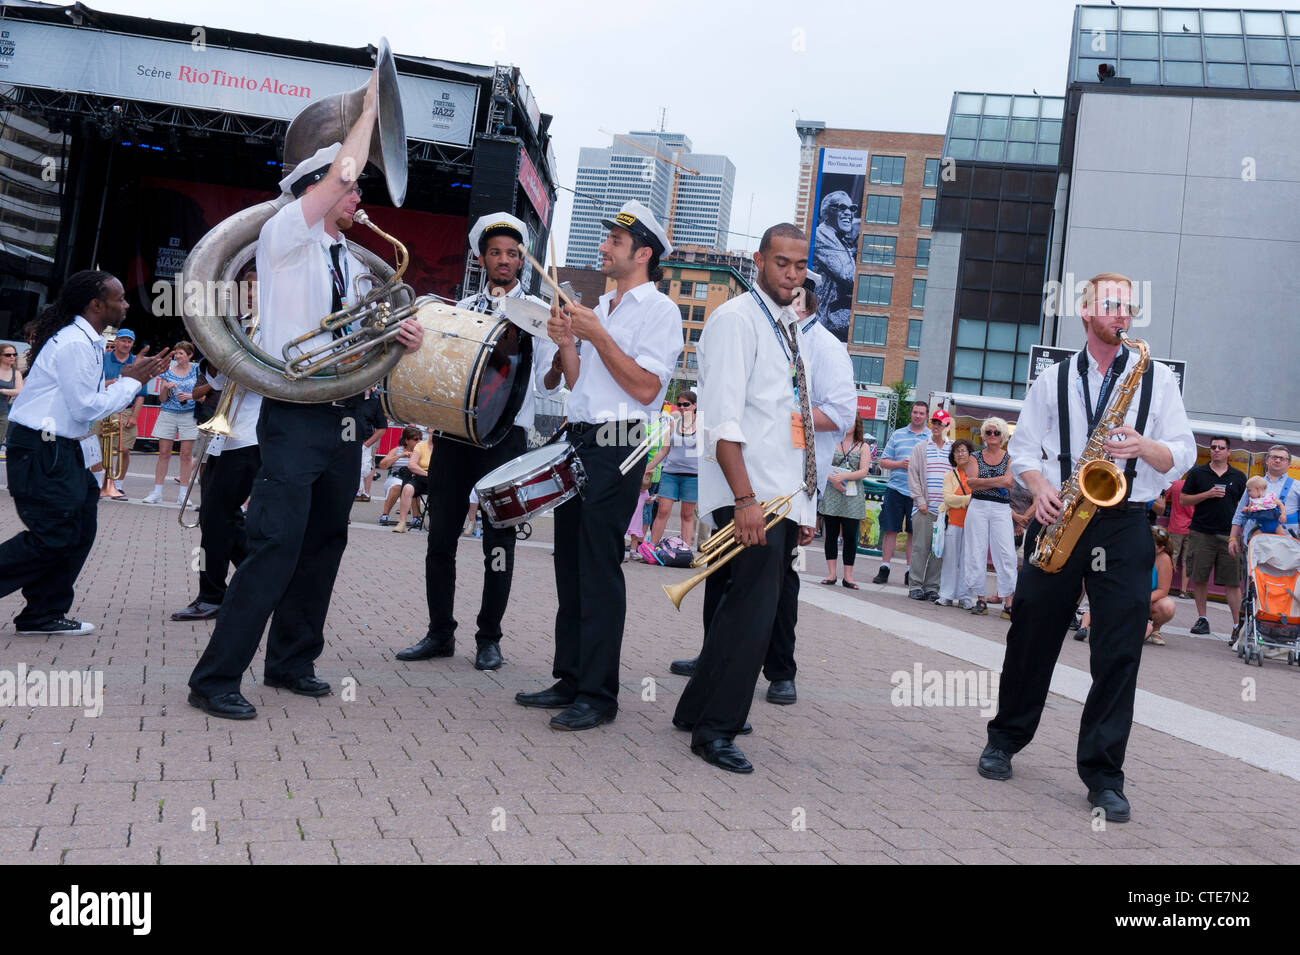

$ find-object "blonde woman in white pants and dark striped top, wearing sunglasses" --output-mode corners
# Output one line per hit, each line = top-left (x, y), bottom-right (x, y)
(962, 417), (1015, 613)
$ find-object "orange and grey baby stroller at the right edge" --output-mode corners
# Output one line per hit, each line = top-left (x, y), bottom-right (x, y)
(1236, 533), (1300, 667)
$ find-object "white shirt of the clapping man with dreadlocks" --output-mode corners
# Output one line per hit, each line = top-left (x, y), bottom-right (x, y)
(9, 316), (140, 440)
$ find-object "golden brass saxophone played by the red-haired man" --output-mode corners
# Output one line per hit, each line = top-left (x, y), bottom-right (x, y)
(1030, 331), (1151, 574)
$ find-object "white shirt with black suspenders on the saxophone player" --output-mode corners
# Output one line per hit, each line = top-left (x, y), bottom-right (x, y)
(1008, 352), (1196, 502)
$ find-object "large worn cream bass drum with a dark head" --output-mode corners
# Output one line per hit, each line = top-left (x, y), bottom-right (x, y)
(380, 296), (533, 448)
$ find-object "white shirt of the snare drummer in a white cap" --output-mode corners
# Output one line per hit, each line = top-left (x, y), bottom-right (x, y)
(567, 282), (685, 425)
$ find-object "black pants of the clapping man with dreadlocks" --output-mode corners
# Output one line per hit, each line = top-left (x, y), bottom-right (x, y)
(0, 422), (99, 630)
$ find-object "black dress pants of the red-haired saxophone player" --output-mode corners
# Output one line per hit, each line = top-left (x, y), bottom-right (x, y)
(988, 505), (1156, 791)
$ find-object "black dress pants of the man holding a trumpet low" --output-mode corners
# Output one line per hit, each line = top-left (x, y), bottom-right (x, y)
(673, 507), (798, 746)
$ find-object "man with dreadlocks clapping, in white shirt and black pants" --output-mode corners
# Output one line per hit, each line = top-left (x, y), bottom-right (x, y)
(0, 270), (170, 635)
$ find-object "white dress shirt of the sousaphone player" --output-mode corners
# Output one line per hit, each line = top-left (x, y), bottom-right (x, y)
(257, 199), (369, 361)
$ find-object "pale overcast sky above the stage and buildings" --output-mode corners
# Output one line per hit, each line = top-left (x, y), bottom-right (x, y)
(87, 0), (1075, 262)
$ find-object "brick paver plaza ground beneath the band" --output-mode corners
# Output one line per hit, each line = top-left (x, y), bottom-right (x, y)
(0, 478), (1300, 864)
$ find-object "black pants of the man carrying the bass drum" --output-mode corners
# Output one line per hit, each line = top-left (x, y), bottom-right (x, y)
(424, 426), (528, 643)
